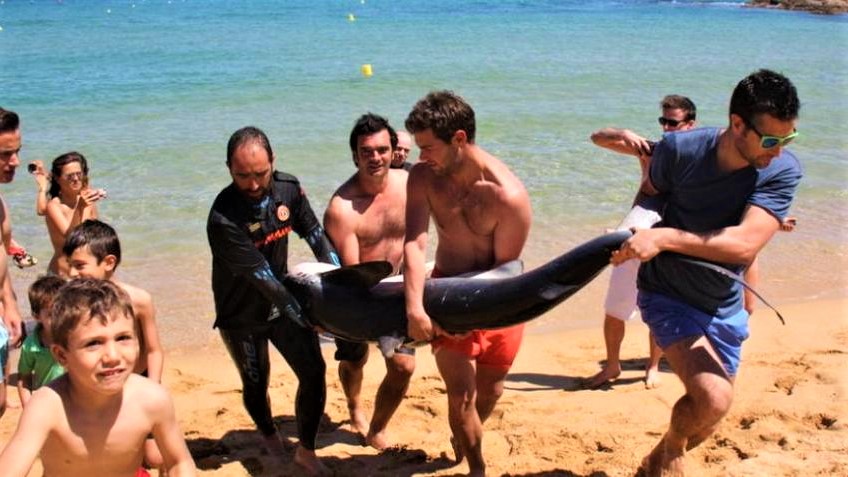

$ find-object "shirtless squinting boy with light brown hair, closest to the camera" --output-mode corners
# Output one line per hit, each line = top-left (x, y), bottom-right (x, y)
(0, 279), (195, 477)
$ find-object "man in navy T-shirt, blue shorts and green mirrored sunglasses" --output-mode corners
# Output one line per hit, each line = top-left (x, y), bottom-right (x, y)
(612, 70), (802, 476)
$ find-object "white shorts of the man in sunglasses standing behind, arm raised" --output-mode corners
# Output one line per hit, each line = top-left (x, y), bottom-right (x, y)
(604, 205), (662, 321)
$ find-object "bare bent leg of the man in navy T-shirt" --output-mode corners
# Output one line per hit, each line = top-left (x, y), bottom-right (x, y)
(643, 336), (733, 476)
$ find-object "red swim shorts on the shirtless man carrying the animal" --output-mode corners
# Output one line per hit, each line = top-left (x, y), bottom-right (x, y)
(431, 323), (524, 371)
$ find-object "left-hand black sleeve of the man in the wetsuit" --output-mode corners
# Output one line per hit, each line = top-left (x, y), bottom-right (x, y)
(207, 212), (308, 327)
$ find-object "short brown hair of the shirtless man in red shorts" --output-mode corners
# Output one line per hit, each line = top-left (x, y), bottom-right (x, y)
(405, 90), (477, 143)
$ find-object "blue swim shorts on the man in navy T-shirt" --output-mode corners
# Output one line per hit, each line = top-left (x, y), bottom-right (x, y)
(638, 290), (748, 377)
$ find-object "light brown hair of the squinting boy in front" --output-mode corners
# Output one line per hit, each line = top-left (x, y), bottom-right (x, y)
(50, 278), (138, 348)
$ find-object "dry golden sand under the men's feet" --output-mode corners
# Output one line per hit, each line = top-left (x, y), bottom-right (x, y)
(0, 300), (848, 477)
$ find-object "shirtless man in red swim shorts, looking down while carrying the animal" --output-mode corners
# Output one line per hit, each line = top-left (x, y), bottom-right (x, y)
(403, 91), (532, 476)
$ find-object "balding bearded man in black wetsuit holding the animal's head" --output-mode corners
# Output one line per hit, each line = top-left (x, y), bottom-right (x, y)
(207, 127), (339, 475)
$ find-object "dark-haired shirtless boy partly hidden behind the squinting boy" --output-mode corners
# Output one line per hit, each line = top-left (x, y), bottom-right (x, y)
(62, 219), (165, 468)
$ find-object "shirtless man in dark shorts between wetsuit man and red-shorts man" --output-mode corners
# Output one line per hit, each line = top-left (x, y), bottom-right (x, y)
(324, 113), (415, 449)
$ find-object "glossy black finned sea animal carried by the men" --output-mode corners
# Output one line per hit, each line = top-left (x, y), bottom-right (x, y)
(284, 231), (632, 356)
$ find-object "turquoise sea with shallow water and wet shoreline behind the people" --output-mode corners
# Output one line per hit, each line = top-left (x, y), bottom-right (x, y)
(0, 0), (848, 344)
